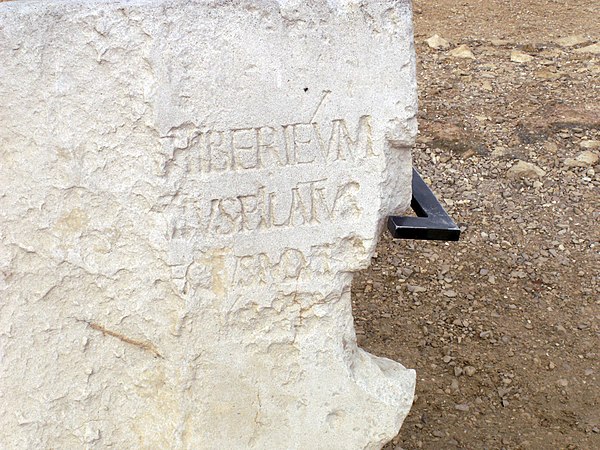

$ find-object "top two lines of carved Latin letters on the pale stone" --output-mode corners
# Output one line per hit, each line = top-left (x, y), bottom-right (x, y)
(165, 115), (376, 239)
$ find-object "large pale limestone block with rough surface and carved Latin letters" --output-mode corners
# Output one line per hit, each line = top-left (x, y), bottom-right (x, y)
(0, 0), (416, 450)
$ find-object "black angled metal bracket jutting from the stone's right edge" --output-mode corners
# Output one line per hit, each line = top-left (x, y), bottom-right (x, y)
(388, 168), (460, 241)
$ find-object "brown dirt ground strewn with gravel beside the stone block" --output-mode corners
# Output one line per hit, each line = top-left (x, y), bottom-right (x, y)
(353, 0), (600, 450)
